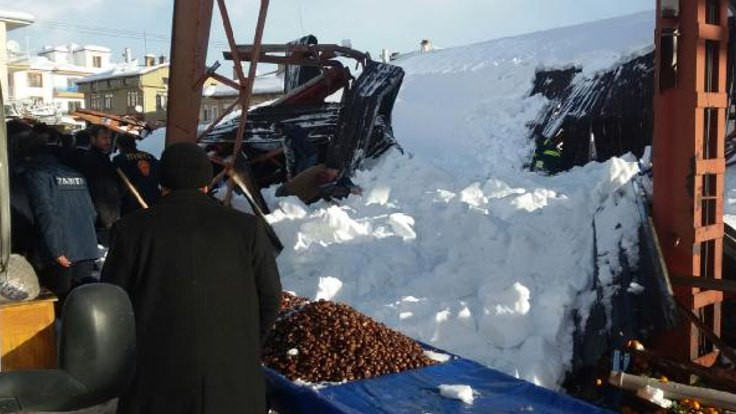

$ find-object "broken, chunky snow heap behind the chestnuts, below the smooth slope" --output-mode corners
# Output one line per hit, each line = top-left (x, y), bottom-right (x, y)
(268, 153), (639, 387)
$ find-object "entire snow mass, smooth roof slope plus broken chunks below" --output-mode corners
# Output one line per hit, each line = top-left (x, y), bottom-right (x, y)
(267, 12), (654, 388)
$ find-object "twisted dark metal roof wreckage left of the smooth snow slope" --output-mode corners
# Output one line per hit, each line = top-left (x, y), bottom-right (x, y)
(201, 36), (404, 191)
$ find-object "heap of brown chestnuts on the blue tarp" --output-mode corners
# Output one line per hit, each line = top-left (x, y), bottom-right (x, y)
(263, 295), (436, 383)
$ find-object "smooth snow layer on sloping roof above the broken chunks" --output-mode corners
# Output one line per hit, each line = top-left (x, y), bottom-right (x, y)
(394, 11), (655, 176)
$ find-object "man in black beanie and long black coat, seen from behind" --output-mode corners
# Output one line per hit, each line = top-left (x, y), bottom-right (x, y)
(102, 143), (281, 414)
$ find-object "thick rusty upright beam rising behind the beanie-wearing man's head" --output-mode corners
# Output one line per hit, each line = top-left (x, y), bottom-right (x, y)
(166, 0), (214, 145)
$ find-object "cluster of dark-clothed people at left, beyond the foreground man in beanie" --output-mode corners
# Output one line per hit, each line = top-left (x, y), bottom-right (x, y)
(7, 121), (160, 306)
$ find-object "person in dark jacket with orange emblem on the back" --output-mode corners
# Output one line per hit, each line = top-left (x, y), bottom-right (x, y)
(112, 135), (161, 217)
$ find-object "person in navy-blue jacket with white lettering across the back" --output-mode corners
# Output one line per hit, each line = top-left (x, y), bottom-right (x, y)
(24, 134), (98, 307)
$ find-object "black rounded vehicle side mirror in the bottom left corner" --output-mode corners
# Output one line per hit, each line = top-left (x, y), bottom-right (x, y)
(0, 283), (135, 413)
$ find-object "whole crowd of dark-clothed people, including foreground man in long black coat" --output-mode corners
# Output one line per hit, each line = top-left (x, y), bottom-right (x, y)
(8, 122), (281, 414)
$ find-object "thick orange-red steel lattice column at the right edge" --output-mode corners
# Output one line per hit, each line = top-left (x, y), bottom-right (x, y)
(653, 0), (729, 366)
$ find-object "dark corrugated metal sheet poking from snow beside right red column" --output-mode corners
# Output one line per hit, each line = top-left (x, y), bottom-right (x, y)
(532, 53), (654, 168)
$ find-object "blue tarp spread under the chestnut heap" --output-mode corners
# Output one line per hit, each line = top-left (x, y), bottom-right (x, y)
(264, 350), (608, 414)
